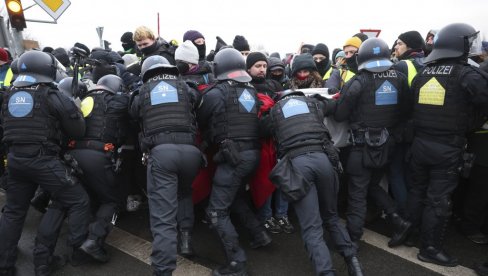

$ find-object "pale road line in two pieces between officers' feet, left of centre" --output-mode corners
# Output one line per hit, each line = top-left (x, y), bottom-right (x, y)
(105, 227), (211, 276)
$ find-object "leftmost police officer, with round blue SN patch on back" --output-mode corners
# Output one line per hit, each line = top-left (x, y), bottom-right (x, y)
(0, 51), (89, 275)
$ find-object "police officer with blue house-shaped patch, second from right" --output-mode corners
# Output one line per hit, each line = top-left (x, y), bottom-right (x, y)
(335, 38), (411, 246)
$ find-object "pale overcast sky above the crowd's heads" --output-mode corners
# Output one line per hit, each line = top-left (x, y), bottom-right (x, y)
(1, 0), (488, 57)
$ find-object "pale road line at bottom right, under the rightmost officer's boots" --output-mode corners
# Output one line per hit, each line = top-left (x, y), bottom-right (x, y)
(362, 226), (477, 276)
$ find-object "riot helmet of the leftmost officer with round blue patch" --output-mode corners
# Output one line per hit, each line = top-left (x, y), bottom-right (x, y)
(14, 51), (57, 87)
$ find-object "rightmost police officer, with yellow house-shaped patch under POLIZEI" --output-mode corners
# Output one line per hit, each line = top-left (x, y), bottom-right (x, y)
(407, 23), (488, 266)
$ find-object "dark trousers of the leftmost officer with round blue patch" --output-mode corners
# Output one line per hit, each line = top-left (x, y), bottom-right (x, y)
(0, 153), (90, 268)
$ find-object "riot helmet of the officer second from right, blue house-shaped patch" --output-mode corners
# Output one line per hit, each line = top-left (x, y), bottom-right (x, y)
(357, 37), (393, 72)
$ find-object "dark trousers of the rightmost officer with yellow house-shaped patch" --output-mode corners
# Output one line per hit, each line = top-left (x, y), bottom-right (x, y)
(407, 137), (462, 249)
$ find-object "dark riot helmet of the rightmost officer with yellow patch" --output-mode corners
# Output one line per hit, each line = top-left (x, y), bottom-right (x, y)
(424, 23), (479, 63)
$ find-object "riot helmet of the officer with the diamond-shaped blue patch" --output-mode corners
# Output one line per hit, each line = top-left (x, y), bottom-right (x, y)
(213, 48), (251, 82)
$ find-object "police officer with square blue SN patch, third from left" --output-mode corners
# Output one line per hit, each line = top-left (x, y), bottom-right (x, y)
(130, 56), (202, 275)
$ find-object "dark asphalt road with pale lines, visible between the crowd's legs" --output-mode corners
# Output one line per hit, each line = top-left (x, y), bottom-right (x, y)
(0, 192), (488, 276)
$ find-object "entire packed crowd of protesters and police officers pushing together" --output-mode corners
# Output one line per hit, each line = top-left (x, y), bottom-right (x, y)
(0, 23), (488, 276)
